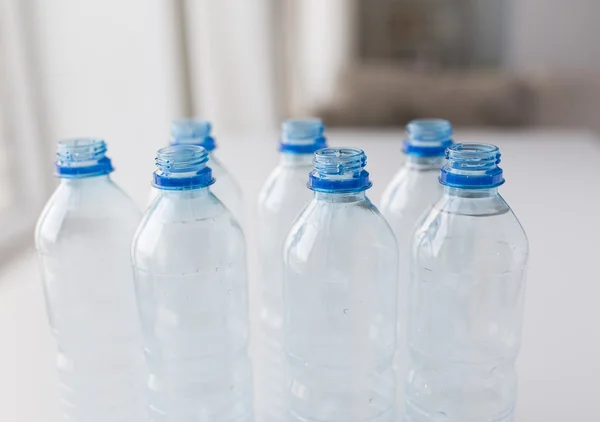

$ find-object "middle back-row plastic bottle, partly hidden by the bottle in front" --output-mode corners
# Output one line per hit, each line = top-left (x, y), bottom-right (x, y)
(256, 119), (326, 422)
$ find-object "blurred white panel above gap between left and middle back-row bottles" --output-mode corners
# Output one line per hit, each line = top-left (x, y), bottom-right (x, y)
(183, 0), (281, 132)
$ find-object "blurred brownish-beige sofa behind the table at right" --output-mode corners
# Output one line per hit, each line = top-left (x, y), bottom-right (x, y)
(306, 64), (600, 131)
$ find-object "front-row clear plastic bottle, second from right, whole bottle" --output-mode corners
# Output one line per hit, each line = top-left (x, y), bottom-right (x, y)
(284, 148), (398, 422)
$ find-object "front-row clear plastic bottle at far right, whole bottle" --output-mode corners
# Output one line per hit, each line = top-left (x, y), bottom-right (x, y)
(405, 144), (528, 422)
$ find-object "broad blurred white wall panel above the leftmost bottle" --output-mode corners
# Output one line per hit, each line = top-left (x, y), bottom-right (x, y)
(32, 0), (187, 203)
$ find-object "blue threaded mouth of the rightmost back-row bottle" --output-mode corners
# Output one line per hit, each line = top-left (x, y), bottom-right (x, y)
(403, 119), (453, 157)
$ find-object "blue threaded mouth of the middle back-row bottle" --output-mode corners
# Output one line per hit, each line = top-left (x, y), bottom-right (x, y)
(279, 119), (327, 154)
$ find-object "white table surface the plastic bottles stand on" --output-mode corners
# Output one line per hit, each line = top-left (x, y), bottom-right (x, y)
(0, 131), (600, 422)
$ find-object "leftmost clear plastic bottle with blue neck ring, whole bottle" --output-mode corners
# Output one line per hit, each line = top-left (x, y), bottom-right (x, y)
(35, 139), (148, 422)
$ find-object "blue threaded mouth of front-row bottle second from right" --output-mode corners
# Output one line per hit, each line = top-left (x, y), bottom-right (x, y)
(308, 148), (372, 193)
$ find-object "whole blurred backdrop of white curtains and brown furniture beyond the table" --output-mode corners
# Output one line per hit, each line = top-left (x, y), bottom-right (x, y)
(0, 0), (600, 260)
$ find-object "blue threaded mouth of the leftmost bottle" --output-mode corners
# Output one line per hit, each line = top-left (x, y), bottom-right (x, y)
(55, 138), (114, 178)
